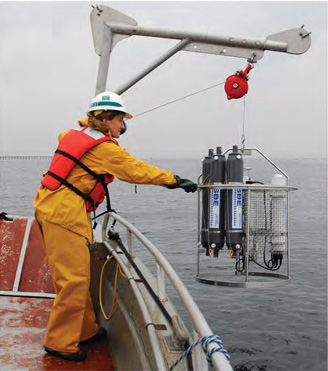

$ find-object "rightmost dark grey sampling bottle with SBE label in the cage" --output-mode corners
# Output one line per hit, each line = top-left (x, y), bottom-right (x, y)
(226, 146), (244, 251)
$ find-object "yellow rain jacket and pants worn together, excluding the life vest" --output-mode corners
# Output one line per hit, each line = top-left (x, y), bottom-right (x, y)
(34, 120), (176, 353)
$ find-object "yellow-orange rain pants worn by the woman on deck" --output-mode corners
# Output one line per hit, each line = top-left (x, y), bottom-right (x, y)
(35, 221), (99, 353)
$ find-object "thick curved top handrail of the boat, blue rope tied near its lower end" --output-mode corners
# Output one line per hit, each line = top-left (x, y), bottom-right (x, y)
(103, 212), (233, 371)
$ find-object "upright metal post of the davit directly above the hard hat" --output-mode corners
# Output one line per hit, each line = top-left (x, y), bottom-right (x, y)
(96, 27), (113, 95)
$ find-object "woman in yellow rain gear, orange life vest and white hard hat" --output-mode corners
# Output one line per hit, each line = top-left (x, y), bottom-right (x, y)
(34, 92), (197, 362)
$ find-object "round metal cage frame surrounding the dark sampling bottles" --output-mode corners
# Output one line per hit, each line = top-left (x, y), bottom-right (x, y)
(196, 148), (297, 288)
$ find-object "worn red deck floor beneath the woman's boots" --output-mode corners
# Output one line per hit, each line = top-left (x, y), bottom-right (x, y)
(0, 296), (114, 371)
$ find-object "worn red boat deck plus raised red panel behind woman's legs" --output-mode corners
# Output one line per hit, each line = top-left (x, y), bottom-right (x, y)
(0, 218), (115, 371)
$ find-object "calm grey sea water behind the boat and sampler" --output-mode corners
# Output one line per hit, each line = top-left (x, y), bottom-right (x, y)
(0, 158), (327, 371)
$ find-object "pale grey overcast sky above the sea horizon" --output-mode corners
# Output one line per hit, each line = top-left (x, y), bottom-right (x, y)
(0, 1), (327, 158)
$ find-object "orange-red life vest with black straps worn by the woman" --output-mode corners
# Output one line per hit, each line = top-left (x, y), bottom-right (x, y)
(41, 127), (117, 211)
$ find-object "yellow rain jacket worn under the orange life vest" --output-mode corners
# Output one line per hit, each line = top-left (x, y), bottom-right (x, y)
(34, 118), (176, 242)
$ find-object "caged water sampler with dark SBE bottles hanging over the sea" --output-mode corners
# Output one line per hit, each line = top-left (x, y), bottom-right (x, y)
(196, 145), (296, 287)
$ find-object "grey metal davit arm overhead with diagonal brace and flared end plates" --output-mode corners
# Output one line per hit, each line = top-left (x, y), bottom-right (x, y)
(90, 5), (311, 94)
